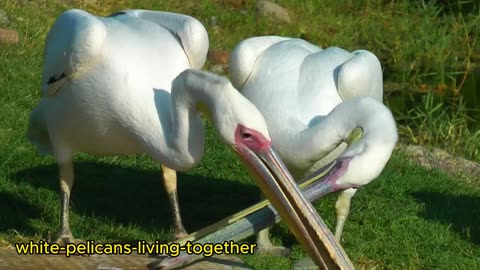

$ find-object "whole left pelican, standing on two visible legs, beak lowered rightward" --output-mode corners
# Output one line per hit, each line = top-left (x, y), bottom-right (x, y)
(27, 10), (351, 268)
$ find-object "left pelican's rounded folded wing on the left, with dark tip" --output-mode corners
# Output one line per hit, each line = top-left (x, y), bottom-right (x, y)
(42, 9), (107, 96)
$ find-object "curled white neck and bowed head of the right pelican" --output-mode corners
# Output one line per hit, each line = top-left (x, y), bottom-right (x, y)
(301, 97), (398, 194)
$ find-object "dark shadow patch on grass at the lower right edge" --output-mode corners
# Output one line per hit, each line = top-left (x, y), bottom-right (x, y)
(412, 191), (480, 245)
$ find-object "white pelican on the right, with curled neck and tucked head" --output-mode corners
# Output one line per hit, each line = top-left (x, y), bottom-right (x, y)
(230, 36), (398, 253)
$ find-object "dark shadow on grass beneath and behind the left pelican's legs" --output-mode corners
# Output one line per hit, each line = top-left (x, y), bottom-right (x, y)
(4, 162), (259, 238)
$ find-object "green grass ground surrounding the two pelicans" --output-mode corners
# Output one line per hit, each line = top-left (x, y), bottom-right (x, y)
(0, 0), (480, 269)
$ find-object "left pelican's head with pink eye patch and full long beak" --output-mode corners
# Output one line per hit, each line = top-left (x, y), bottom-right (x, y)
(172, 70), (351, 269)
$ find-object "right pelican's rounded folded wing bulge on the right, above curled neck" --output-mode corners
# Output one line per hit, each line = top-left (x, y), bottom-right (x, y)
(337, 50), (383, 102)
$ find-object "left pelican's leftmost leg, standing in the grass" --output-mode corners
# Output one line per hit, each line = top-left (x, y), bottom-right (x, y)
(55, 162), (80, 245)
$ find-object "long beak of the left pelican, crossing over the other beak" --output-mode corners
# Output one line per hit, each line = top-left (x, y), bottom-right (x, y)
(235, 145), (354, 269)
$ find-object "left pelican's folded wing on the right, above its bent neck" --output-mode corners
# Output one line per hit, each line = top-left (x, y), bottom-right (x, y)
(122, 9), (208, 69)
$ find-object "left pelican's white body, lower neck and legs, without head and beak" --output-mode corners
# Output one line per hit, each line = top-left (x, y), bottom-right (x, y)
(27, 10), (208, 242)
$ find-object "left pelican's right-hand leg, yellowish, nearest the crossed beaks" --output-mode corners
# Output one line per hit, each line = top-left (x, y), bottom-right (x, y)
(161, 165), (187, 239)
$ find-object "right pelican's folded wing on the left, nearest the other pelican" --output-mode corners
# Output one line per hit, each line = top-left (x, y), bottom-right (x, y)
(229, 36), (292, 88)
